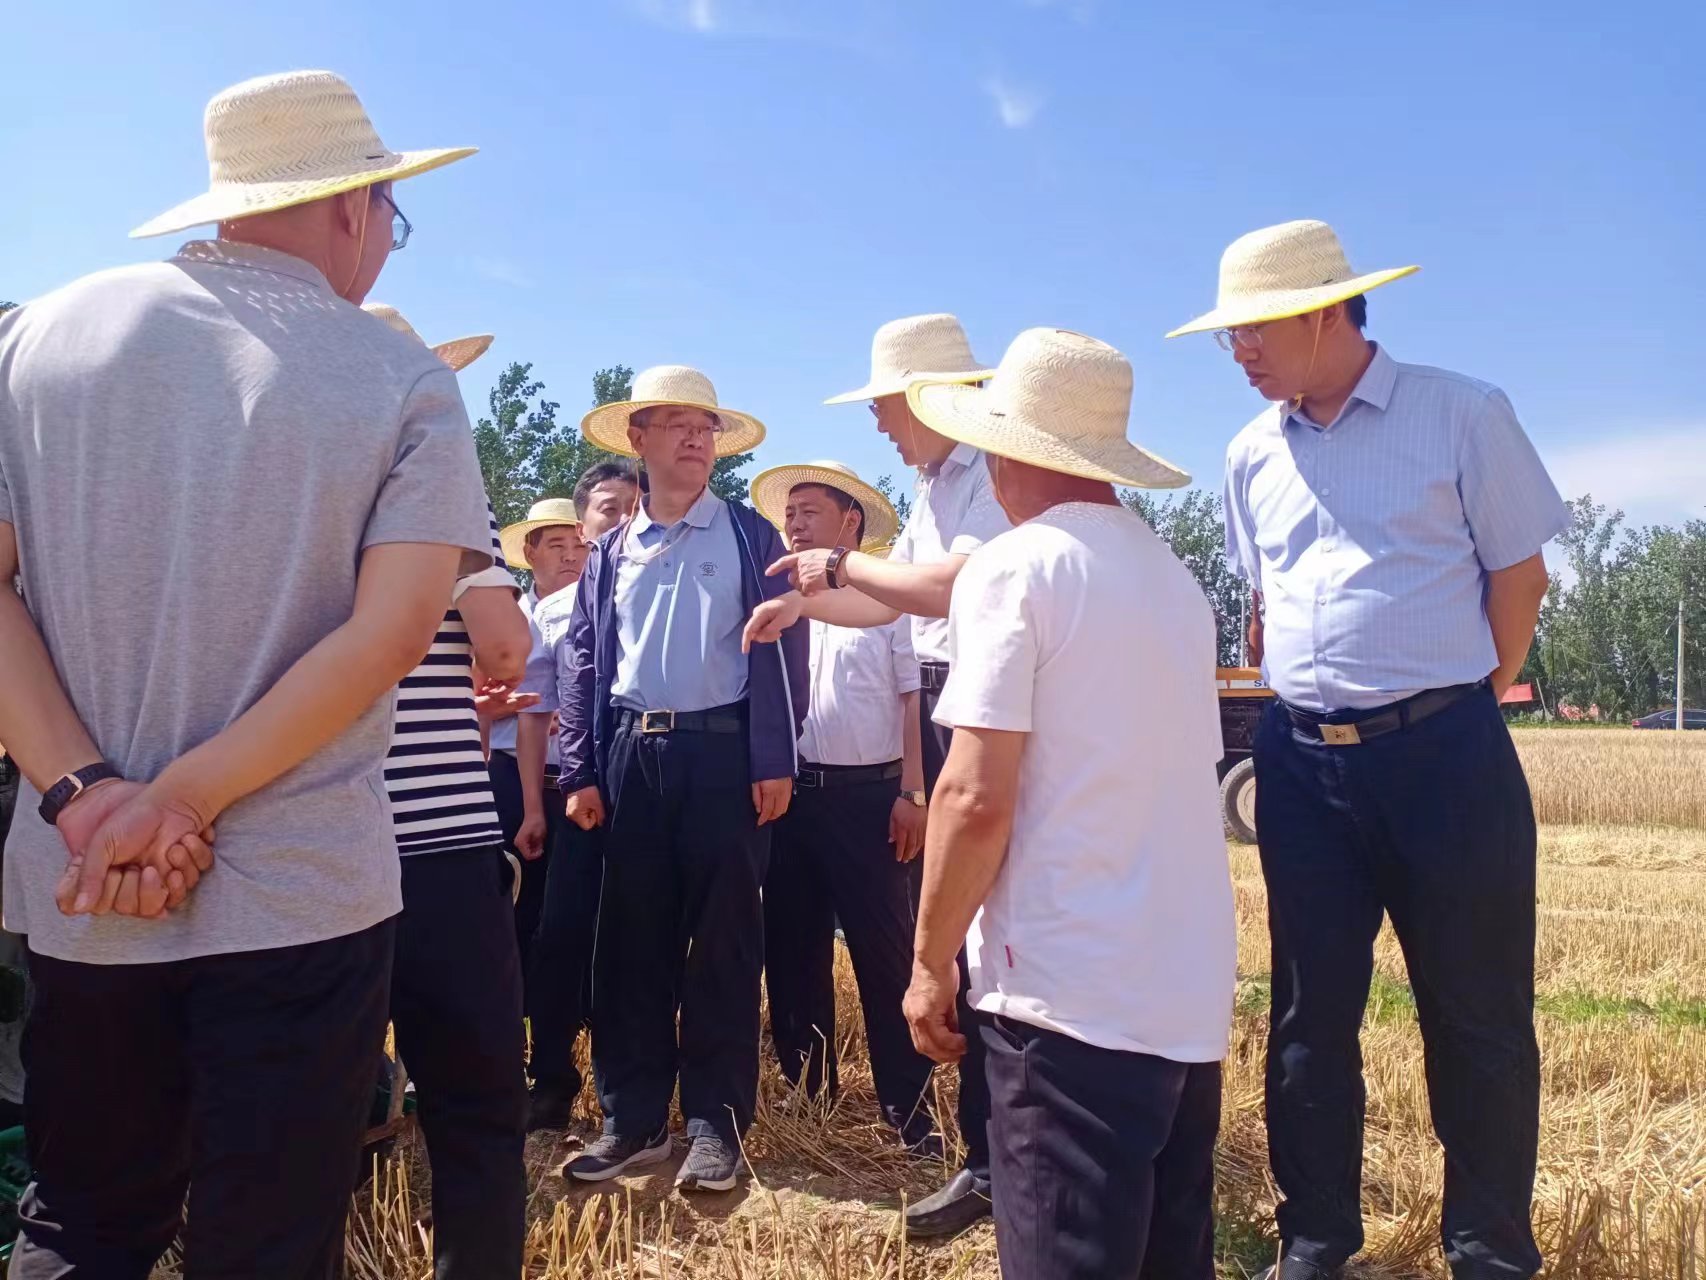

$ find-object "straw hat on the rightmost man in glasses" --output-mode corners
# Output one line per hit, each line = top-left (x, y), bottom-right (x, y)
(1167, 220), (1421, 338)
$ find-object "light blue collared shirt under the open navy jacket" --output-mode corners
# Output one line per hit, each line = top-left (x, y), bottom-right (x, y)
(611, 490), (747, 712)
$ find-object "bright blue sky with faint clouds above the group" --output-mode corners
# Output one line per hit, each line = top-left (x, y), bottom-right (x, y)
(13, 0), (1706, 522)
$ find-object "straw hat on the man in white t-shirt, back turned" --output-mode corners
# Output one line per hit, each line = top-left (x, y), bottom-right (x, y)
(906, 329), (1191, 488)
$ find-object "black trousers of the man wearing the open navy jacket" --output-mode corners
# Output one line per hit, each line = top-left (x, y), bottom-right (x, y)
(592, 727), (771, 1140)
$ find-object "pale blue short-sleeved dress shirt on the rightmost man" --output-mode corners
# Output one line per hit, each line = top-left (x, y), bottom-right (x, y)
(1225, 348), (1570, 712)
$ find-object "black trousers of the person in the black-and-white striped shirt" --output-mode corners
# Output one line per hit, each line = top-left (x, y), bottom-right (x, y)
(391, 847), (527, 1280)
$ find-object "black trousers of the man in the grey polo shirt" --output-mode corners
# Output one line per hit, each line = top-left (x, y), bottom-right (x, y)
(9, 920), (396, 1280)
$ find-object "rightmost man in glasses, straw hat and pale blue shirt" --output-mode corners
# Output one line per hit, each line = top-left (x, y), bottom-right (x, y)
(1169, 222), (1568, 1280)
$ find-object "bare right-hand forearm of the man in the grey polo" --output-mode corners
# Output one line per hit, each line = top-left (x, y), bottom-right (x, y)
(154, 543), (461, 823)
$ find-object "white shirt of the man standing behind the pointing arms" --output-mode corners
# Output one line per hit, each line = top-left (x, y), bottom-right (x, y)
(800, 618), (918, 765)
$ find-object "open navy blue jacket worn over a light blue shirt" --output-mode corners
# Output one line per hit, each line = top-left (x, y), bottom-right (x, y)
(558, 502), (810, 802)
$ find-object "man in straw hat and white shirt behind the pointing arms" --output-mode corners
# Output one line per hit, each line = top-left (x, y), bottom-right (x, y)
(752, 463), (942, 1155)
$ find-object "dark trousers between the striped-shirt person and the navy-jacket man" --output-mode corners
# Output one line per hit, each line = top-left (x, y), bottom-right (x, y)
(522, 821), (604, 1094)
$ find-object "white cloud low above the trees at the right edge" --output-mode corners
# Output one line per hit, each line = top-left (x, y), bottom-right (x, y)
(1547, 425), (1706, 524)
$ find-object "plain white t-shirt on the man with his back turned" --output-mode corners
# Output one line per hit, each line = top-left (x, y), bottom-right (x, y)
(935, 503), (1235, 1062)
